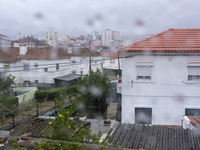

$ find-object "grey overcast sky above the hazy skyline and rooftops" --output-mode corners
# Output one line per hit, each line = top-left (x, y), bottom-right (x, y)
(0, 0), (200, 38)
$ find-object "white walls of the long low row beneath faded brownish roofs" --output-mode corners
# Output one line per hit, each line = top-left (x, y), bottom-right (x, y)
(0, 56), (101, 84)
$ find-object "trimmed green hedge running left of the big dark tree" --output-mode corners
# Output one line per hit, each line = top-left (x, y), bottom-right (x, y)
(35, 85), (77, 102)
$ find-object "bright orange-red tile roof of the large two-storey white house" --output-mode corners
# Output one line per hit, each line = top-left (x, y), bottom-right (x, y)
(119, 28), (200, 53)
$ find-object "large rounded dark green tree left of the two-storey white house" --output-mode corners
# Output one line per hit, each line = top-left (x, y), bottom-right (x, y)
(77, 69), (110, 118)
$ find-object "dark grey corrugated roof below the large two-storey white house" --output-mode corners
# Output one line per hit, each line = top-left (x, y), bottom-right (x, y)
(107, 123), (200, 150)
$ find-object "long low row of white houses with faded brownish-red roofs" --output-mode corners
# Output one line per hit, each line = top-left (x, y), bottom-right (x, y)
(0, 47), (101, 84)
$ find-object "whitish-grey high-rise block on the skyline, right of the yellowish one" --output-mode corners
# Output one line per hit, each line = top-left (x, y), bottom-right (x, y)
(102, 29), (120, 47)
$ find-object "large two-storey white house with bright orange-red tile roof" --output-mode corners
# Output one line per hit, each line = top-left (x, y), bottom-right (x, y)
(119, 29), (200, 125)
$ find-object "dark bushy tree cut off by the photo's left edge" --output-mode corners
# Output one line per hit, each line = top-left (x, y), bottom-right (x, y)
(0, 72), (15, 96)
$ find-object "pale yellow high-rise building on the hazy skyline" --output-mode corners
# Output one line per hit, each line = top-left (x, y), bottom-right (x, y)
(46, 31), (58, 45)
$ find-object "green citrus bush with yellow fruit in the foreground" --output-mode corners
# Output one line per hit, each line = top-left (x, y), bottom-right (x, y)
(40, 96), (106, 150)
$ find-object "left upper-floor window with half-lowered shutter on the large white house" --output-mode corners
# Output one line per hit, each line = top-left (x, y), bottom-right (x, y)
(136, 66), (152, 80)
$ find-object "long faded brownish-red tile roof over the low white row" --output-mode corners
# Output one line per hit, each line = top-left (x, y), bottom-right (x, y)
(0, 47), (100, 62)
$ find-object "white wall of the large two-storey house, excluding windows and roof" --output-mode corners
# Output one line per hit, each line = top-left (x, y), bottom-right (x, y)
(122, 55), (200, 125)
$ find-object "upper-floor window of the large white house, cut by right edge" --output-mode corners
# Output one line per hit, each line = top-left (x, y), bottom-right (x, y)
(188, 66), (200, 81)
